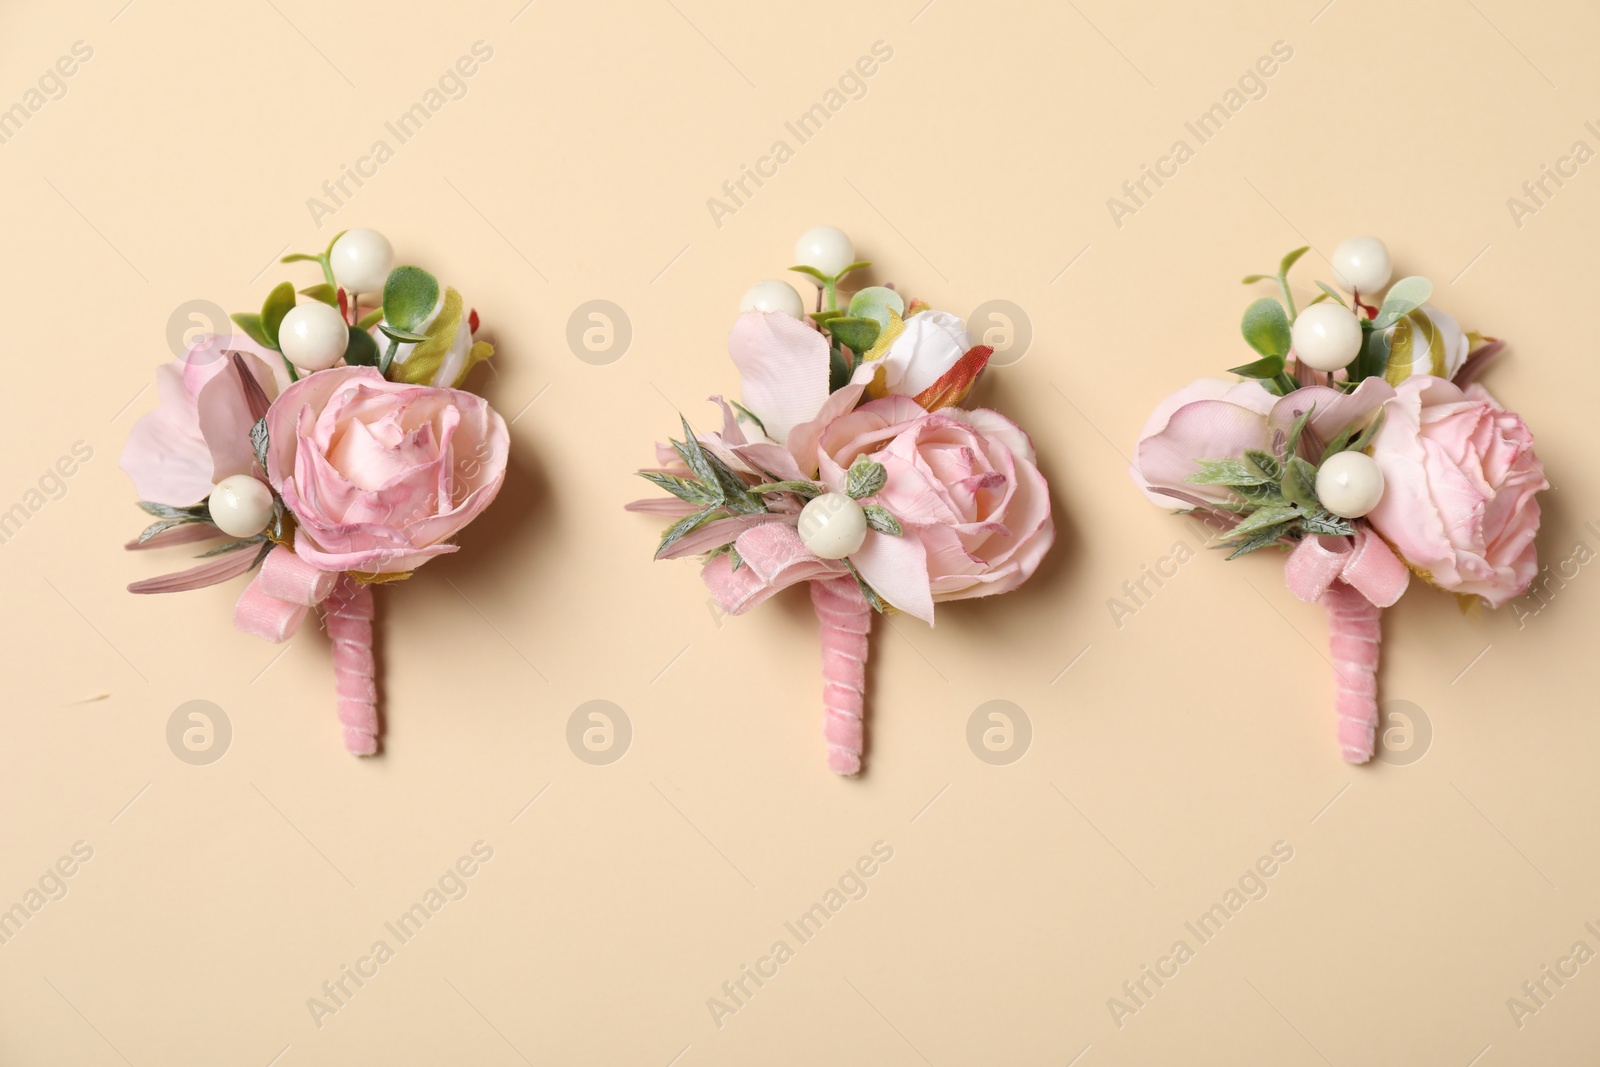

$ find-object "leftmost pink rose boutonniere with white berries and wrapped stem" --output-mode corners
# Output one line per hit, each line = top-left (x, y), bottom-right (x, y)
(122, 230), (510, 755)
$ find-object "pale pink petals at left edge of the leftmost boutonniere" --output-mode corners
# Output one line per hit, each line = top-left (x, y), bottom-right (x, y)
(122, 336), (288, 507)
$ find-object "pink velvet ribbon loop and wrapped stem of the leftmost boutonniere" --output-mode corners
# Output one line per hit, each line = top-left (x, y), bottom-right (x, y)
(234, 545), (378, 755)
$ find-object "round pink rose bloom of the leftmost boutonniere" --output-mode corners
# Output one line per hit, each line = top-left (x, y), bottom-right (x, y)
(267, 366), (510, 574)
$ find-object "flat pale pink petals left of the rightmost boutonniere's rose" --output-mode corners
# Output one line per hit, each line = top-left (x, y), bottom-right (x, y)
(1128, 378), (1394, 507)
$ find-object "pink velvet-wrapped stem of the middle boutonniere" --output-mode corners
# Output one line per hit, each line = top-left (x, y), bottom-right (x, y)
(810, 574), (872, 774)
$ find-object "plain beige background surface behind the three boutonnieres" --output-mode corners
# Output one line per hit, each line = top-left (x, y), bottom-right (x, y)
(0, 0), (1600, 1067)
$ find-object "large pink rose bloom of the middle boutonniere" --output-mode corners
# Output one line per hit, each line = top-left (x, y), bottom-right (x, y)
(816, 395), (1056, 624)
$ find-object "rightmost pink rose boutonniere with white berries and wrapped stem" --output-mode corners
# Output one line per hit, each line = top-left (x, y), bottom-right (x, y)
(1131, 237), (1549, 763)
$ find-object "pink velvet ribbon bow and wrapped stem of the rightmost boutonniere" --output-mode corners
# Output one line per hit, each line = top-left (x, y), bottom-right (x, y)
(1283, 523), (1411, 763)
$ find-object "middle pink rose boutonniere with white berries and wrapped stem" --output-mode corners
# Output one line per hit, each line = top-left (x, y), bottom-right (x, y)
(627, 226), (1054, 774)
